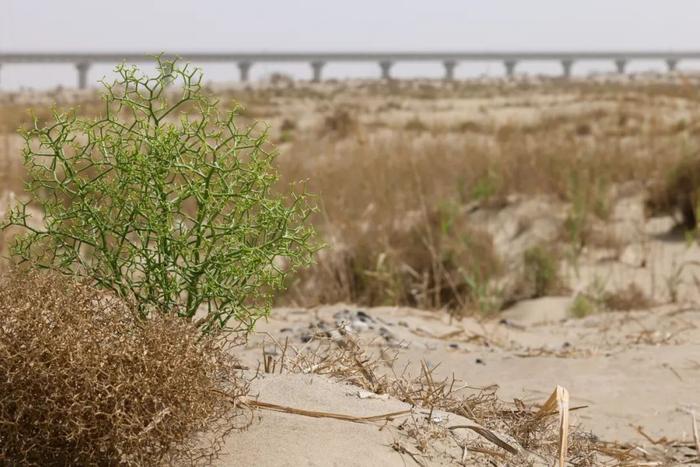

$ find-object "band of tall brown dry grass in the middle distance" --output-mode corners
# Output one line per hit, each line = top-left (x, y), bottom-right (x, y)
(280, 104), (683, 311)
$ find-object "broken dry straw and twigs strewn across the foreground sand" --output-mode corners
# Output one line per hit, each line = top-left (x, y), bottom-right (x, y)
(260, 328), (692, 466)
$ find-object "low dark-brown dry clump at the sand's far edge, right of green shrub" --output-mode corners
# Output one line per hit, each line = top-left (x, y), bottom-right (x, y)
(288, 201), (501, 312)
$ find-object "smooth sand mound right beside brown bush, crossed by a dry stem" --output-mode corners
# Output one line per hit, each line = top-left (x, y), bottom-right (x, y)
(219, 374), (410, 467)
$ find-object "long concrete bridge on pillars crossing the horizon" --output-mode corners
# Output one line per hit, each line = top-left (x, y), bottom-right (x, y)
(0, 50), (700, 89)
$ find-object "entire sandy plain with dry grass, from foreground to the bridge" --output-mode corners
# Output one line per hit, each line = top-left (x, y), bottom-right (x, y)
(0, 74), (700, 465)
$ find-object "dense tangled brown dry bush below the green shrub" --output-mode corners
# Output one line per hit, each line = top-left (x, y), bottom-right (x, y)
(0, 271), (252, 466)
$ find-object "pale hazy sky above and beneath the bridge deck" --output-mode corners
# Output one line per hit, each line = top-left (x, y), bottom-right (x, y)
(0, 0), (700, 89)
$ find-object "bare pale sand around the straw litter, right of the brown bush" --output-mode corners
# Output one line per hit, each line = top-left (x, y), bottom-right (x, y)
(221, 199), (700, 466)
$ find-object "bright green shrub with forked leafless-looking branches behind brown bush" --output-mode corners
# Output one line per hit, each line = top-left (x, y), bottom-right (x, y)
(4, 59), (313, 330)
